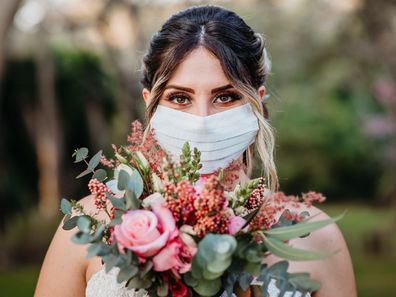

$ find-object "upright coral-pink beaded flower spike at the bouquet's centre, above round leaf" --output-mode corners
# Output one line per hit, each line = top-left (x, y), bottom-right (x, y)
(194, 175), (229, 237)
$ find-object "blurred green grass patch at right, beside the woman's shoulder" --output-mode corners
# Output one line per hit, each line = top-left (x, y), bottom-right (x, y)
(322, 204), (396, 297)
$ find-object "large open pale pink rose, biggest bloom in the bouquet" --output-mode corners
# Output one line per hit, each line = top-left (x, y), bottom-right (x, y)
(114, 203), (178, 258)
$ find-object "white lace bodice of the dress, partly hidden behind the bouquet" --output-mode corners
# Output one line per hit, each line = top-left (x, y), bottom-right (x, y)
(85, 266), (311, 297)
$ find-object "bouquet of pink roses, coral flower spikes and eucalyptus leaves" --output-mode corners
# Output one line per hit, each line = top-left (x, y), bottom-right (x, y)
(61, 121), (338, 297)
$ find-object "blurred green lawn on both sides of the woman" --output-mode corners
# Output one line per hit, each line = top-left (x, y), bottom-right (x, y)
(0, 203), (396, 297)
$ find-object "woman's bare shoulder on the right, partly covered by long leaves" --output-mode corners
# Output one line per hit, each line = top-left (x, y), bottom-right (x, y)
(280, 203), (357, 297)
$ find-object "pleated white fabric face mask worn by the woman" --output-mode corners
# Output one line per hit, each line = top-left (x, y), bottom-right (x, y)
(150, 103), (259, 174)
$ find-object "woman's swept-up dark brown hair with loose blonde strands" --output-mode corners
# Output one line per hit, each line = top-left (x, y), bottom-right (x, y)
(140, 5), (279, 191)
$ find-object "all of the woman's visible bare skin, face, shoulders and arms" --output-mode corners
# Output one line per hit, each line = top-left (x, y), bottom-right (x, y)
(34, 48), (357, 297)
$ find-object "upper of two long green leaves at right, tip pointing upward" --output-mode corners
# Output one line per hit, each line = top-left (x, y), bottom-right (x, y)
(264, 212), (345, 240)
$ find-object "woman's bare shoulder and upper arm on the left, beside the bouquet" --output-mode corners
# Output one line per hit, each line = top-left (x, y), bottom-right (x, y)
(34, 195), (99, 297)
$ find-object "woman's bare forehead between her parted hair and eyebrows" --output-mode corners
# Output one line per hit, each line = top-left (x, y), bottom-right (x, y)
(168, 47), (229, 89)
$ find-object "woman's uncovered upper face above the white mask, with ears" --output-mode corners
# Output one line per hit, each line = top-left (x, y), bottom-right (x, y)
(142, 47), (265, 116)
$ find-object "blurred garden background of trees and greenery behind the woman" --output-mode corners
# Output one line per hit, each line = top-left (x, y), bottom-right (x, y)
(0, 0), (396, 297)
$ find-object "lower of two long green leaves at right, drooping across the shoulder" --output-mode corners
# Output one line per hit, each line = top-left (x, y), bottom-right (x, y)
(264, 237), (337, 261)
